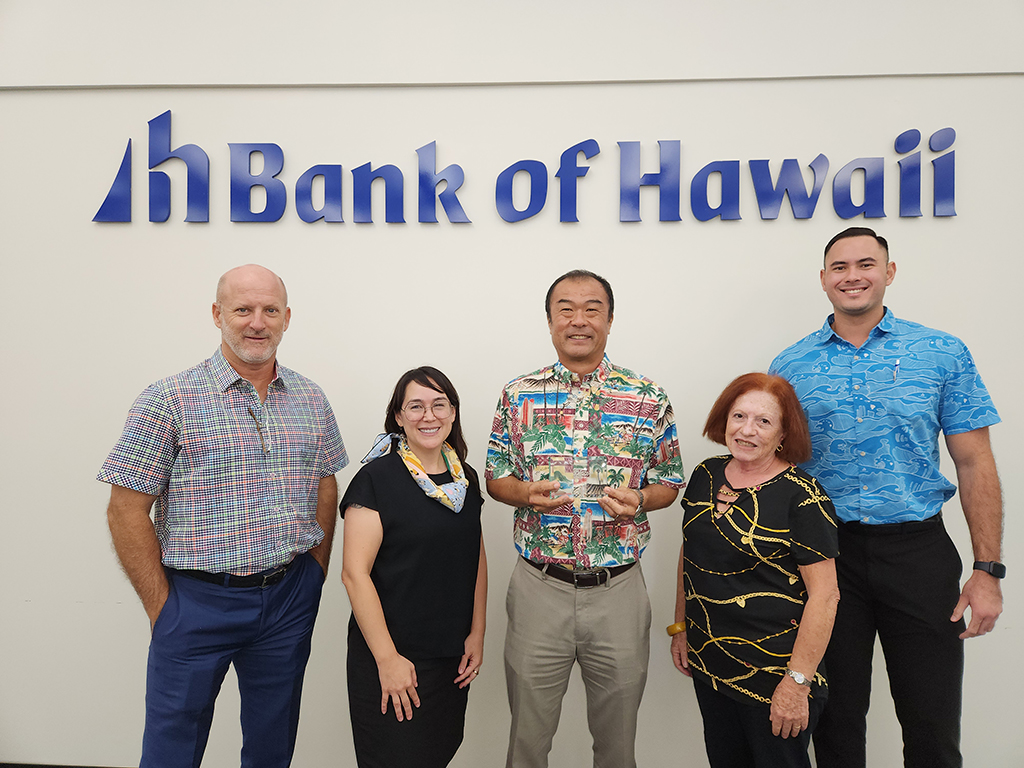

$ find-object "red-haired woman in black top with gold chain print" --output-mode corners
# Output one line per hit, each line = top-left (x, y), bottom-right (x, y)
(669, 374), (839, 768)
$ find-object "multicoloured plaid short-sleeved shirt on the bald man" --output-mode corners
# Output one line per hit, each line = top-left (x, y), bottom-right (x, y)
(97, 348), (348, 574)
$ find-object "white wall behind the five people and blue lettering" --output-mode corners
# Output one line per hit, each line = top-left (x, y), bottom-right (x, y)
(0, 1), (1024, 768)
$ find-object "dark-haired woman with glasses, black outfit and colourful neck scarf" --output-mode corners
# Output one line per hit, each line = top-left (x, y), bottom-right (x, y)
(341, 367), (487, 768)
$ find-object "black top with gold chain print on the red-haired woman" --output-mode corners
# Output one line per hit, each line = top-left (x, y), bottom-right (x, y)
(682, 456), (839, 703)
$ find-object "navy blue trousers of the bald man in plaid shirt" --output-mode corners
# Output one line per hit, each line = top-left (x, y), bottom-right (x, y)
(140, 553), (324, 768)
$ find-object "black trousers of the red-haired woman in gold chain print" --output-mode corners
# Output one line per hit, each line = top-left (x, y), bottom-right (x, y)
(693, 678), (825, 768)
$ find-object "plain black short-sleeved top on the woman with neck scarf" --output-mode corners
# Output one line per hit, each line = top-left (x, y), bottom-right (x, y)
(341, 453), (483, 660)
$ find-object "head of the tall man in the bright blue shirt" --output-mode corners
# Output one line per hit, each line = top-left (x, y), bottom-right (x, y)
(821, 236), (896, 322)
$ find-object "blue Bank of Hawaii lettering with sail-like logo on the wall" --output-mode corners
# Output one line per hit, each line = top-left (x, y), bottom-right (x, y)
(92, 111), (956, 224)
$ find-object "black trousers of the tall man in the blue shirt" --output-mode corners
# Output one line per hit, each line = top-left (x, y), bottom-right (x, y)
(814, 515), (965, 768)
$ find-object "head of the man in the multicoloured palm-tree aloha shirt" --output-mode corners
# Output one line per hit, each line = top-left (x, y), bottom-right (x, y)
(548, 278), (612, 374)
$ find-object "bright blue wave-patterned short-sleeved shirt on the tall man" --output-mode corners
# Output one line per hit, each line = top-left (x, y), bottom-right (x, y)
(771, 309), (999, 524)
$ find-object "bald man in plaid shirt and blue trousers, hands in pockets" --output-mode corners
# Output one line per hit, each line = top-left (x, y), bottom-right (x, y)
(98, 264), (348, 767)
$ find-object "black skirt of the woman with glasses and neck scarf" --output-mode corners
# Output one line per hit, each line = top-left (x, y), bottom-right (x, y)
(347, 631), (469, 768)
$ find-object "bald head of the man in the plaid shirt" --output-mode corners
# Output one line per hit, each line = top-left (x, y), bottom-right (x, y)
(213, 264), (292, 370)
